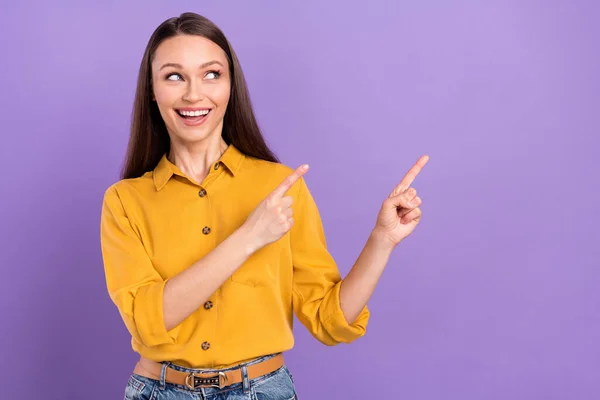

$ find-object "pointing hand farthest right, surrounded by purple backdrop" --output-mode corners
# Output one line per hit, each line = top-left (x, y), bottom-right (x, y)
(373, 155), (429, 246)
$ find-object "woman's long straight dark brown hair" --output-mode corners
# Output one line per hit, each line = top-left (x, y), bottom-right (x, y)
(121, 12), (279, 179)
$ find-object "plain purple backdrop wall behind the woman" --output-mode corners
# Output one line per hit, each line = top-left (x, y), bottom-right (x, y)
(0, 0), (600, 400)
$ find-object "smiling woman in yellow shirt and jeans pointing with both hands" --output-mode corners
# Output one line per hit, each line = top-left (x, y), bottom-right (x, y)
(101, 13), (427, 400)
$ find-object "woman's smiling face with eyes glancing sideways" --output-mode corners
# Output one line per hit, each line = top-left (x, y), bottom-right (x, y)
(152, 35), (231, 143)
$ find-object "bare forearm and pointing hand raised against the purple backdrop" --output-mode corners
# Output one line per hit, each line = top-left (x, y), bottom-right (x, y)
(340, 156), (429, 323)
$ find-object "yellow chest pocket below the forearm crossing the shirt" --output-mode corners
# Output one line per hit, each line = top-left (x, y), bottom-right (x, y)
(230, 240), (283, 287)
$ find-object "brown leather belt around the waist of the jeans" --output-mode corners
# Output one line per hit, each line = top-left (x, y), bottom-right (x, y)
(133, 354), (283, 390)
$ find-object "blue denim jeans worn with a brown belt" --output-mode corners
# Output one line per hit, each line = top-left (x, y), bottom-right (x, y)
(125, 355), (297, 400)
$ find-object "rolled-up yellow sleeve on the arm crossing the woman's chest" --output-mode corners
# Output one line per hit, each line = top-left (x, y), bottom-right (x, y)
(100, 186), (179, 347)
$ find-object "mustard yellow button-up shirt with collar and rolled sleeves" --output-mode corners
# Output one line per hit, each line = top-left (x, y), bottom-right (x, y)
(101, 145), (369, 368)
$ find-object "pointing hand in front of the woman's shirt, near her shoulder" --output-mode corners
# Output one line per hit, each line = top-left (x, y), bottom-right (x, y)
(240, 164), (308, 253)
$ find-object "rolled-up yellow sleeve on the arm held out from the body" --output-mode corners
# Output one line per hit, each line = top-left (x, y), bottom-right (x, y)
(290, 178), (370, 346)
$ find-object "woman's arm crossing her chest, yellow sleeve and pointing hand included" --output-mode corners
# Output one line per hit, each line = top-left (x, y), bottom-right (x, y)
(101, 168), (307, 346)
